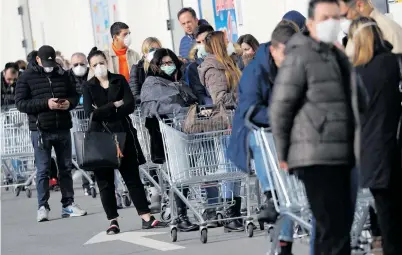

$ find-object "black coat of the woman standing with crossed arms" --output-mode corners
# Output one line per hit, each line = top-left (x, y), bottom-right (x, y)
(83, 72), (146, 165)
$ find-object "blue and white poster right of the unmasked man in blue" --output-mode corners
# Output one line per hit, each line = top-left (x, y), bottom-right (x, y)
(212, 0), (239, 42)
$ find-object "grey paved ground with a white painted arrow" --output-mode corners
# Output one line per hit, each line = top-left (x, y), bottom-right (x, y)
(1, 185), (308, 255)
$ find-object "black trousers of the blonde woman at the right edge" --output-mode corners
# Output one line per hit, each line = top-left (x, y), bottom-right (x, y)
(370, 169), (402, 255)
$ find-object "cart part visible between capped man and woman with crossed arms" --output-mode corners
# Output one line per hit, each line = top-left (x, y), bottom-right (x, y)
(70, 106), (97, 198)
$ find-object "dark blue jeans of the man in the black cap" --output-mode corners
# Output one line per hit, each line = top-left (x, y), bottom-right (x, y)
(31, 130), (74, 209)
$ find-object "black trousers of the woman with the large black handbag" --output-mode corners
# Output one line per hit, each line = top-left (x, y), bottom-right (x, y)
(94, 138), (151, 220)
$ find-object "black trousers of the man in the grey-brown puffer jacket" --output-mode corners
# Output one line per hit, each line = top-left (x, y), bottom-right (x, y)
(295, 165), (354, 255)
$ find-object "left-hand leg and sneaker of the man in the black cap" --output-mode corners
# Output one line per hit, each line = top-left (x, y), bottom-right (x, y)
(31, 131), (52, 221)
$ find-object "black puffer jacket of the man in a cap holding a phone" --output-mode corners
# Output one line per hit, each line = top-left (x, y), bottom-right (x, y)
(15, 62), (78, 132)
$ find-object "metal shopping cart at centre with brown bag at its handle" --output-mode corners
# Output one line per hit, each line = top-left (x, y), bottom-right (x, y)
(159, 112), (254, 243)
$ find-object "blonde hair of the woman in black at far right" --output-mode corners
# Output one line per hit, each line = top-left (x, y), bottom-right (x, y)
(348, 17), (384, 66)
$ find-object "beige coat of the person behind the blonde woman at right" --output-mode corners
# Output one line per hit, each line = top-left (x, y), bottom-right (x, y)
(346, 9), (402, 59)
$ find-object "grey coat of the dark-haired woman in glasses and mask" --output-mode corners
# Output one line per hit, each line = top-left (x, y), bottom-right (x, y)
(141, 76), (186, 117)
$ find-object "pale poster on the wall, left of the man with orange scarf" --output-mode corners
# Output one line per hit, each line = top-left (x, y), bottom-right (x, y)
(90, 0), (111, 50)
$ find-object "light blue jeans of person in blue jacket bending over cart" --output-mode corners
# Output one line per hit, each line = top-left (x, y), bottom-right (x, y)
(249, 134), (294, 242)
